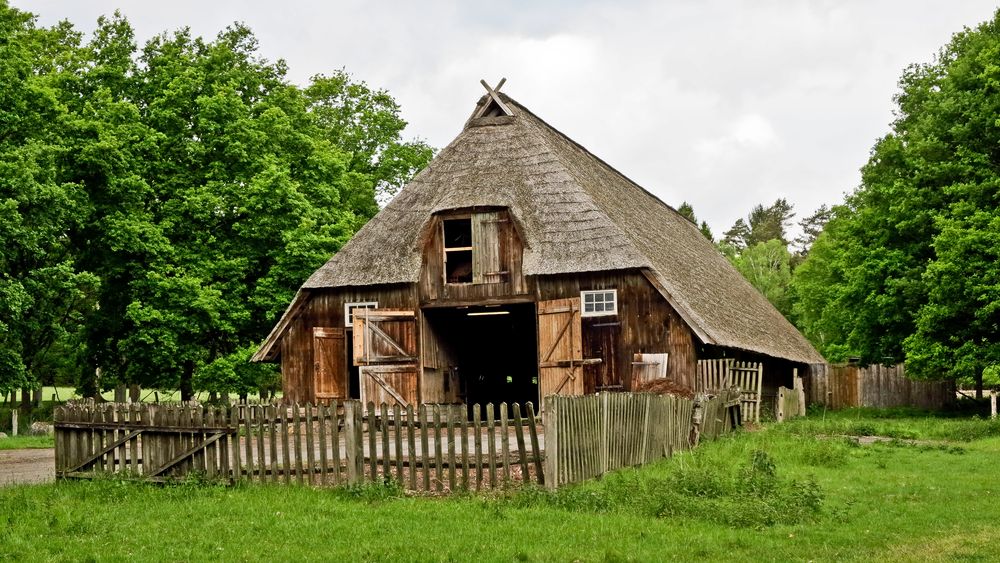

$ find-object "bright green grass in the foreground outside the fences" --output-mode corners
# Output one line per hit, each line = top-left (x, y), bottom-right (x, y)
(0, 411), (1000, 561)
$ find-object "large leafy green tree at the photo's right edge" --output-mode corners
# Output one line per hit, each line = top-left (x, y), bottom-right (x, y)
(796, 12), (1000, 392)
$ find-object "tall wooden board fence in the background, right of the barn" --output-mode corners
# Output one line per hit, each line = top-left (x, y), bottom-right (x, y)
(806, 364), (955, 409)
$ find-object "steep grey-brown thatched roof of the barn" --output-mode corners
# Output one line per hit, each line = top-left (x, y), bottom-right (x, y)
(258, 94), (823, 363)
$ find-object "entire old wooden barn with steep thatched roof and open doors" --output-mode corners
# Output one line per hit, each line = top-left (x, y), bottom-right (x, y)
(253, 82), (823, 405)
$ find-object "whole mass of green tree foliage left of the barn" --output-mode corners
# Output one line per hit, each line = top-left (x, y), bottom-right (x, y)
(0, 3), (431, 396)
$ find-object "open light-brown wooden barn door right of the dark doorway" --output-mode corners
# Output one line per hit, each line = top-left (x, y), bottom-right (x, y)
(538, 297), (593, 402)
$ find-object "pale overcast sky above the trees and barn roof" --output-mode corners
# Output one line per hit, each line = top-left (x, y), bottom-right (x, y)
(13, 0), (996, 235)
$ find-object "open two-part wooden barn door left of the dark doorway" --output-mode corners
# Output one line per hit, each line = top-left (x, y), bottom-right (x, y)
(352, 309), (419, 406)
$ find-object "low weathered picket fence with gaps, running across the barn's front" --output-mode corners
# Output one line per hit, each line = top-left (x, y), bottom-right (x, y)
(55, 401), (544, 492)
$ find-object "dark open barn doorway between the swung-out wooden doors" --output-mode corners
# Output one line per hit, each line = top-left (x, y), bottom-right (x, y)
(424, 303), (538, 414)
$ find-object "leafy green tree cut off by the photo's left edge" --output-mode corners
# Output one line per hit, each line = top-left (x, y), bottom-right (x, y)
(0, 3), (96, 398)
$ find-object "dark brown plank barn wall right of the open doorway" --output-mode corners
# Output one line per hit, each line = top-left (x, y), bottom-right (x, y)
(536, 270), (698, 393)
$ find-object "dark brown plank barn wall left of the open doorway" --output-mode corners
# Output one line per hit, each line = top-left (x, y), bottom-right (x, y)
(281, 284), (419, 402)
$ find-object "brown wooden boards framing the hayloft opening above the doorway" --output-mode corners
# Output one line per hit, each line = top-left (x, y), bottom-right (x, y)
(420, 212), (531, 303)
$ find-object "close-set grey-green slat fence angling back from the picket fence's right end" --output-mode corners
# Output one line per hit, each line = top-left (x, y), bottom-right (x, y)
(545, 393), (739, 488)
